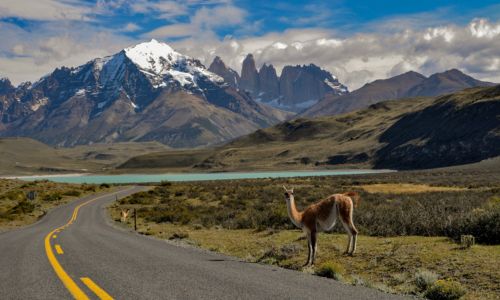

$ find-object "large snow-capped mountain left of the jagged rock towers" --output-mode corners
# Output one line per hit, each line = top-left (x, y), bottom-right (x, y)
(0, 40), (288, 147)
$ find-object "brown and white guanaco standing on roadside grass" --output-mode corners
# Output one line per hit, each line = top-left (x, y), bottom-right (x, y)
(283, 186), (360, 266)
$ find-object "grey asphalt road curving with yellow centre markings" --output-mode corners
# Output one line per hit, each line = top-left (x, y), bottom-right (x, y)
(0, 187), (401, 299)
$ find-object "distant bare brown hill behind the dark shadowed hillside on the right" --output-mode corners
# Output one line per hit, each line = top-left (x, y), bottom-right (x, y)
(301, 69), (495, 117)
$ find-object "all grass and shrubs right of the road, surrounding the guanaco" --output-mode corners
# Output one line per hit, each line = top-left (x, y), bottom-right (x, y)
(110, 170), (500, 299)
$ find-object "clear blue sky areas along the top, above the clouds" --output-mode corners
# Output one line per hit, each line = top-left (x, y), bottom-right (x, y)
(0, 0), (500, 40)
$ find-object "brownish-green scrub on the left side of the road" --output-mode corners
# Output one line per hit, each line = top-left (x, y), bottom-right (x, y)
(0, 179), (109, 231)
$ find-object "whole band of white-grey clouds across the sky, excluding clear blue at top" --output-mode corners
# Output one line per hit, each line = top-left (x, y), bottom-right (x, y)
(0, 0), (500, 90)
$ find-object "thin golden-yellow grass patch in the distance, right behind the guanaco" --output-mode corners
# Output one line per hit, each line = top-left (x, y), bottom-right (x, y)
(359, 183), (465, 194)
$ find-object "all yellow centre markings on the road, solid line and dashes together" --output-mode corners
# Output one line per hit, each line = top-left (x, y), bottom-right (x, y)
(45, 187), (133, 300)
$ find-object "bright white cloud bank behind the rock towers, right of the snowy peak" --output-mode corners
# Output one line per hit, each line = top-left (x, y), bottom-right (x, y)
(175, 19), (500, 89)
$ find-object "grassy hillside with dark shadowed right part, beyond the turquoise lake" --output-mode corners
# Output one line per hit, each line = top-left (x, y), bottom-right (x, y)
(120, 85), (500, 171)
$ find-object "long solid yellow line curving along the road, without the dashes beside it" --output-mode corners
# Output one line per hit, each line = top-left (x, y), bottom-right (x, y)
(45, 187), (133, 300)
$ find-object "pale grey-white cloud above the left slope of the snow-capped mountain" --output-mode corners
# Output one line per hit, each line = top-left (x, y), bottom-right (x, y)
(0, 22), (135, 84)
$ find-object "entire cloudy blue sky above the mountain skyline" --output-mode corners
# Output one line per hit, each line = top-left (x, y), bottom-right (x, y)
(0, 0), (500, 87)
